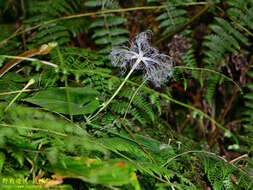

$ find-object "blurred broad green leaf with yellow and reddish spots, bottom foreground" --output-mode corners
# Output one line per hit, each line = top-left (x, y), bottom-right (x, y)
(55, 157), (140, 189)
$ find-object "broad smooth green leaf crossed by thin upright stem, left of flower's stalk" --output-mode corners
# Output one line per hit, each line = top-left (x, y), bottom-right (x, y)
(25, 87), (99, 115)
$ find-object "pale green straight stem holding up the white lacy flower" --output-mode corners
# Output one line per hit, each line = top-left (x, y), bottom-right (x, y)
(88, 57), (142, 122)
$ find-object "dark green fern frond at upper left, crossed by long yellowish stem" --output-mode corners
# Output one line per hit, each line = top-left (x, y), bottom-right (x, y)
(24, 0), (80, 48)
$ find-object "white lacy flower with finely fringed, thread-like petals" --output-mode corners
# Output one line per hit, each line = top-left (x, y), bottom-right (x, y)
(110, 30), (173, 87)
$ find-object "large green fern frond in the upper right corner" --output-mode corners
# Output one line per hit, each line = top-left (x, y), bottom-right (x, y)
(204, 0), (253, 66)
